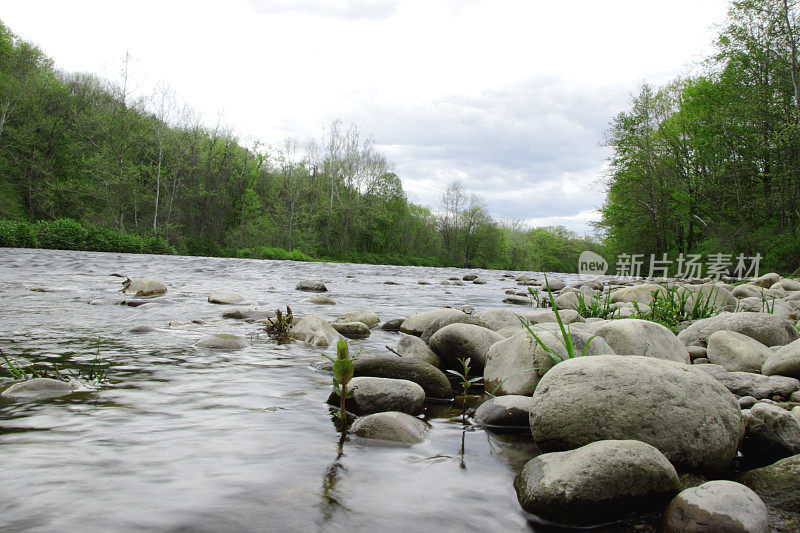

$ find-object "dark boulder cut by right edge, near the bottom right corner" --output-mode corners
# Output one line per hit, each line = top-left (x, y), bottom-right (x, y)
(739, 455), (800, 513)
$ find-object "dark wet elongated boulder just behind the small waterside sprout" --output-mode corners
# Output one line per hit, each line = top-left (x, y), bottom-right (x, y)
(353, 354), (453, 399)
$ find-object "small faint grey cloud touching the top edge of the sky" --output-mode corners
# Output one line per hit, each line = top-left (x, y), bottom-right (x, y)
(249, 0), (399, 20)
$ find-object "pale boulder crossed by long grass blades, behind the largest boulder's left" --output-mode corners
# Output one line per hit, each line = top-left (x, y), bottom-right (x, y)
(483, 326), (613, 396)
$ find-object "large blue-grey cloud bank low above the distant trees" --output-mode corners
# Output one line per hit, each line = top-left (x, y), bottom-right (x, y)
(344, 78), (629, 232)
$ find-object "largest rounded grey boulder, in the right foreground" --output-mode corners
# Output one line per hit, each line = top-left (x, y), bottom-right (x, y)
(530, 355), (744, 472)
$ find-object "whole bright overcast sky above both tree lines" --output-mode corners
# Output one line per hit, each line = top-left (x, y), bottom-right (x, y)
(0, 0), (727, 233)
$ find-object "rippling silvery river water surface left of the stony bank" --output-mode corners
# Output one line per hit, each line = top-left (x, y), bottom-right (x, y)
(0, 249), (556, 531)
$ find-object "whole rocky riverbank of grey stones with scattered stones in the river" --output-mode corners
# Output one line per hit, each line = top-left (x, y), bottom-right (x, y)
(0, 264), (800, 531)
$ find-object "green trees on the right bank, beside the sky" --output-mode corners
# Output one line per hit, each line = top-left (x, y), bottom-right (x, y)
(598, 0), (800, 273)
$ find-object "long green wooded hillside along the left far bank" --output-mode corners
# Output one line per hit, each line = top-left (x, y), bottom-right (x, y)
(0, 19), (597, 270)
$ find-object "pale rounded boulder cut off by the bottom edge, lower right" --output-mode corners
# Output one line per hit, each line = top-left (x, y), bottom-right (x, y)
(661, 480), (770, 533)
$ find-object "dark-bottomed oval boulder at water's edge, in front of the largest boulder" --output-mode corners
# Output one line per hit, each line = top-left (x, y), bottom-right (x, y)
(514, 440), (679, 524)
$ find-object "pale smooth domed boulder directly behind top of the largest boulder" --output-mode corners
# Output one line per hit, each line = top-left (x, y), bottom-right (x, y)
(594, 318), (689, 364)
